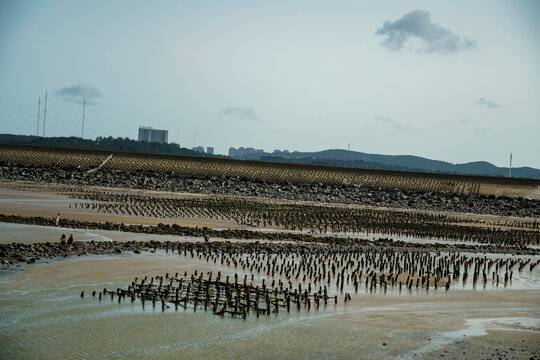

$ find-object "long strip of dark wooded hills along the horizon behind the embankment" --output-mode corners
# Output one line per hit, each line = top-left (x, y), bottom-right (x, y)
(0, 134), (540, 179)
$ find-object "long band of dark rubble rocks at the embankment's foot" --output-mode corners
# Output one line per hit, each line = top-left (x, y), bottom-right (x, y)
(0, 162), (540, 218)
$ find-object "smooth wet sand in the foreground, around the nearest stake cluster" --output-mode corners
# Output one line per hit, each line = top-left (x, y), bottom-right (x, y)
(0, 253), (540, 359)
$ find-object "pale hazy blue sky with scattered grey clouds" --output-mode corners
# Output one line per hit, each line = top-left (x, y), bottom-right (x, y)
(0, 0), (540, 168)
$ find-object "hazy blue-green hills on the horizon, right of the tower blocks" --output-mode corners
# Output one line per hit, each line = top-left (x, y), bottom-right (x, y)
(235, 149), (540, 179)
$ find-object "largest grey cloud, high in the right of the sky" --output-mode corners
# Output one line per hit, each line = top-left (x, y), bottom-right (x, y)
(375, 10), (476, 53)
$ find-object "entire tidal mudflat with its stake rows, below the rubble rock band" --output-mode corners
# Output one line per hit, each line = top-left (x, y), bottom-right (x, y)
(0, 162), (540, 359)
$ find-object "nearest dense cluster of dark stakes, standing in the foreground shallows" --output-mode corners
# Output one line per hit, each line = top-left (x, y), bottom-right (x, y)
(85, 272), (351, 318)
